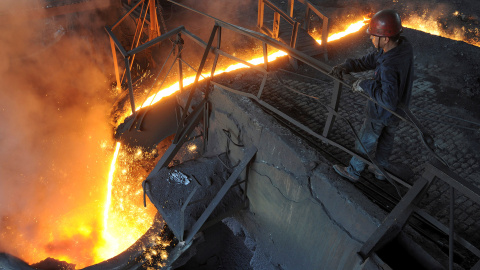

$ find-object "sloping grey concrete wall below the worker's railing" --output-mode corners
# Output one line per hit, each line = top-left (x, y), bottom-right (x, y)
(202, 88), (390, 269)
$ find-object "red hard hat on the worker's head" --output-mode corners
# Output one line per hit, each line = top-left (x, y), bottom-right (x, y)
(367, 10), (403, 37)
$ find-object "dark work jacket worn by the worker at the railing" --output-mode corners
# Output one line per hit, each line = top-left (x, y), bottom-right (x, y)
(343, 37), (413, 125)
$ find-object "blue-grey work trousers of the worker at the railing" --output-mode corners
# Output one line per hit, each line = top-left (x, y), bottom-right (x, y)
(347, 117), (398, 176)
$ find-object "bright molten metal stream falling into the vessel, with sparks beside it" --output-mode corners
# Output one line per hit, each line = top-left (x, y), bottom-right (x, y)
(94, 142), (157, 262)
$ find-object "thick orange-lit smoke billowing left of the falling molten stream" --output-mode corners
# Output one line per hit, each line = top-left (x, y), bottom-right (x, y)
(0, 0), (113, 263)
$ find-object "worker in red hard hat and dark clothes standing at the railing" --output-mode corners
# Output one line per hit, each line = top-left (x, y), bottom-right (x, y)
(330, 10), (414, 182)
